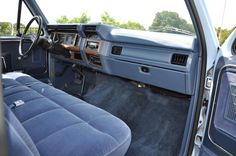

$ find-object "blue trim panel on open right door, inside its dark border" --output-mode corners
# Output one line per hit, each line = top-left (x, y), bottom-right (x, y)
(209, 64), (236, 153)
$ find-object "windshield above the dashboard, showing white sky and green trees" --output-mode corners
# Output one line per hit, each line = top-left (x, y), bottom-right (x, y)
(36, 0), (194, 35)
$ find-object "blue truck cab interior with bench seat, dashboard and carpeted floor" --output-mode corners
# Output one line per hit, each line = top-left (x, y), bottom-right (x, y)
(0, 1), (205, 156)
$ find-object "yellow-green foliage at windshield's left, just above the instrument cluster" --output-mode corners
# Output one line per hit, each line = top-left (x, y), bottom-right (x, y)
(56, 12), (90, 23)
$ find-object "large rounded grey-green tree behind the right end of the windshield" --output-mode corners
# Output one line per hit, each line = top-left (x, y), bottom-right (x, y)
(149, 11), (194, 33)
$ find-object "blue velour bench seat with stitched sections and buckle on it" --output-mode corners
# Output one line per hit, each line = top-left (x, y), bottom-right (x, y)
(3, 74), (131, 156)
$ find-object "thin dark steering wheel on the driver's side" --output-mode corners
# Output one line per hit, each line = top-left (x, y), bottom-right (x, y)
(19, 16), (42, 56)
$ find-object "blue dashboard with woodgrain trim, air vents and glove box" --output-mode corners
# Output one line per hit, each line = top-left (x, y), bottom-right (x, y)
(47, 24), (199, 95)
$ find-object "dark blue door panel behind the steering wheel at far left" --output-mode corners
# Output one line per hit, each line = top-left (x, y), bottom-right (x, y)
(1, 37), (47, 77)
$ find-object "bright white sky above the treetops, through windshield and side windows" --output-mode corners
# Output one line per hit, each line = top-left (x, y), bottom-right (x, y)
(0, 0), (236, 29)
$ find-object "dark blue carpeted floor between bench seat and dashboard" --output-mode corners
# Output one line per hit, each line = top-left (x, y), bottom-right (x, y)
(83, 74), (190, 156)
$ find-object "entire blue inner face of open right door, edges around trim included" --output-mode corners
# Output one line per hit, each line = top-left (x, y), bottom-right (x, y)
(200, 56), (236, 155)
